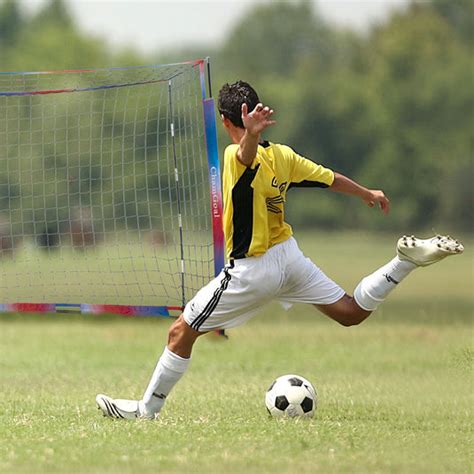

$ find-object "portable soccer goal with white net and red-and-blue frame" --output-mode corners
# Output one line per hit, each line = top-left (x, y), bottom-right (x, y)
(0, 60), (223, 315)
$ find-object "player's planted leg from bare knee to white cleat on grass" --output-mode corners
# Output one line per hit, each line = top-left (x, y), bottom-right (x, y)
(96, 315), (205, 420)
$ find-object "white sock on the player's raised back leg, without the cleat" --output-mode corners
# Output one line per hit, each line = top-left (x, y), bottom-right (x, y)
(354, 256), (417, 311)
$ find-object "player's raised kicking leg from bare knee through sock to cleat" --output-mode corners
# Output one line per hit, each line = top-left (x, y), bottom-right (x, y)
(316, 235), (464, 326)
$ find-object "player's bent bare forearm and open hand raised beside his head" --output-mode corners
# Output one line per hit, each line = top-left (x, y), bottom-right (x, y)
(237, 104), (275, 166)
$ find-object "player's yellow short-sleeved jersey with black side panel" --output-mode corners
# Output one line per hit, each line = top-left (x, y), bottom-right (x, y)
(222, 142), (334, 259)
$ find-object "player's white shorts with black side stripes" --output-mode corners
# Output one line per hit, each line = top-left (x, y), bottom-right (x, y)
(183, 237), (345, 332)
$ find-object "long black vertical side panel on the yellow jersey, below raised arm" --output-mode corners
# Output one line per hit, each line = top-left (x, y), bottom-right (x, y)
(230, 164), (260, 258)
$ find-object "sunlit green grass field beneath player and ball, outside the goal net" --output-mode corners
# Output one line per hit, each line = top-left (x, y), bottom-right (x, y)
(0, 231), (474, 473)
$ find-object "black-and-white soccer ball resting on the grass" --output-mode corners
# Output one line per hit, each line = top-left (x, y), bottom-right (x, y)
(265, 375), (317, 418)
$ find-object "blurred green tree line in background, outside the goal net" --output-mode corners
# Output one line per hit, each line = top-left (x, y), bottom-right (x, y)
(0, 0), (474, 236)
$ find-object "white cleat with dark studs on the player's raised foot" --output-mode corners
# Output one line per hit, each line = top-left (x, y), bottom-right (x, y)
(397, 235), (464, 267)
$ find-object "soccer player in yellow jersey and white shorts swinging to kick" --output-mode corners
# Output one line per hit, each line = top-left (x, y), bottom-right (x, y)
(96, 81), (463, 419)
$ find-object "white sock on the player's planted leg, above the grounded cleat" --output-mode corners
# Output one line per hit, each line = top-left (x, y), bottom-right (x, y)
(138, 347), (190, 415)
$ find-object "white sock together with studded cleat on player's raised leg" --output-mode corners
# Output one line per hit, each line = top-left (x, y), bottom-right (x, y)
(354, 235), (464, 311)
